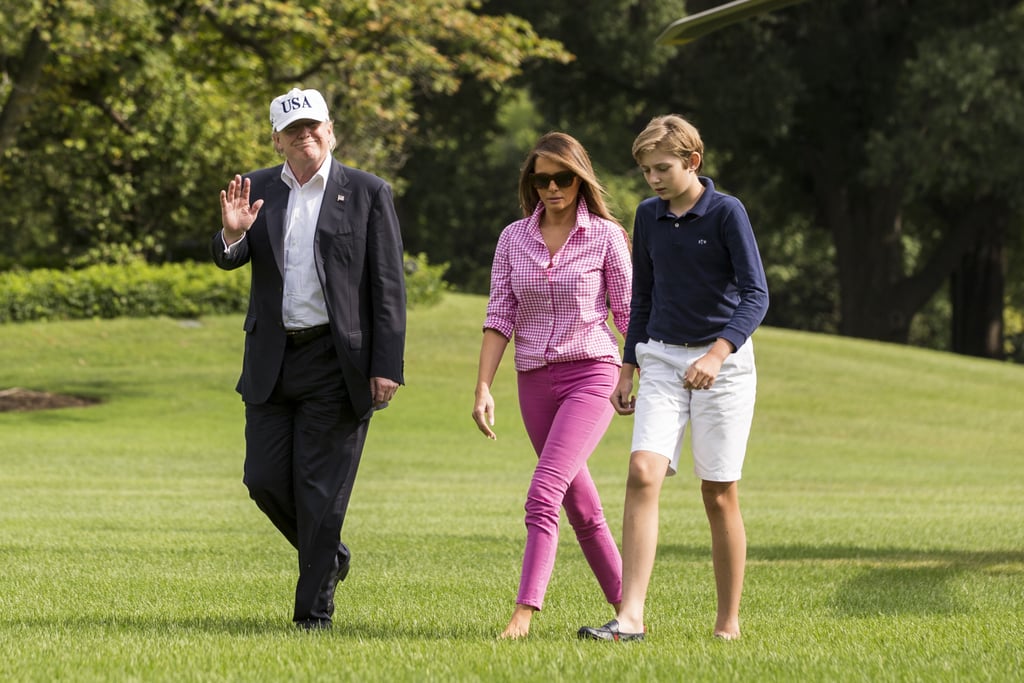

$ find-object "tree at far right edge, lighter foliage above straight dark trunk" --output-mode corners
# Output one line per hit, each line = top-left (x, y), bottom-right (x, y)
(871, 10), (1024, 358)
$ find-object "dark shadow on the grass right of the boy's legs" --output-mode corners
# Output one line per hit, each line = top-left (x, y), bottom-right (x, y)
(658, 546), (1024, 616)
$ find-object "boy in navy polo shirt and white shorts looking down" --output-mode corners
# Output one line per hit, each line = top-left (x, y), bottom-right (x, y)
(579, 115), (768, 641)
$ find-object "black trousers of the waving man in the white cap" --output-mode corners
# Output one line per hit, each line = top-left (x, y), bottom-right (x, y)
(244, 335), (370, 622)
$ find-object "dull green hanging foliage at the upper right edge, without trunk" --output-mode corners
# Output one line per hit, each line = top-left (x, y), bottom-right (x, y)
(866, 8), (1024, 205)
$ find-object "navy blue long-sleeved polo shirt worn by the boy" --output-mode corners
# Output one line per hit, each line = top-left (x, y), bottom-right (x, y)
(623, 176), (768, 365)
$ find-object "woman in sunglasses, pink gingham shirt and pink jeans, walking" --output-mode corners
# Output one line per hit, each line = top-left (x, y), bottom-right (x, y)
(473, 132), (632, 638)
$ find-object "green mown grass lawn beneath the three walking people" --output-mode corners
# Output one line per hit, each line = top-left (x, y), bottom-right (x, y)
(0, 295), (1024, 682)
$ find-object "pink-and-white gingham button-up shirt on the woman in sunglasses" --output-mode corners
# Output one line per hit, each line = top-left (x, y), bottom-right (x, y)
(483, 197), (633, 373)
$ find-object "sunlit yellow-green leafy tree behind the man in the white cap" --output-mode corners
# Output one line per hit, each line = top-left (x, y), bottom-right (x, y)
(0, 0), (558, 267)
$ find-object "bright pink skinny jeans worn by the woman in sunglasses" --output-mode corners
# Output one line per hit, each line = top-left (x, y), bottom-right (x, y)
(516, 360), (623, 609)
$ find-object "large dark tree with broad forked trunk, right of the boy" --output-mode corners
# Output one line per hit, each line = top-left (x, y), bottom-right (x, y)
(674, 0), (1024, 348)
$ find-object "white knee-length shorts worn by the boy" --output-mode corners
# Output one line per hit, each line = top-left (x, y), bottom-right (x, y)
(633, 339), (758, 481)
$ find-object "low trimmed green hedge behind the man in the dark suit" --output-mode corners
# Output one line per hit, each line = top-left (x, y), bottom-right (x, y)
(0, 254), (447, 323)
